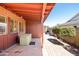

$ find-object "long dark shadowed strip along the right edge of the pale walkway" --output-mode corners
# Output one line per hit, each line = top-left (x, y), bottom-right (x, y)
(47, 38), (79, 56)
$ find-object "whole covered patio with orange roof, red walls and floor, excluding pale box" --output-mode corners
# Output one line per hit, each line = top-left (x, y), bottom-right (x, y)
(0, 3), (55, 56)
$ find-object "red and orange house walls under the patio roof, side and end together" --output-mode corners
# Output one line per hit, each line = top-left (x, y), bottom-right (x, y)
(0, 6), (43, 50)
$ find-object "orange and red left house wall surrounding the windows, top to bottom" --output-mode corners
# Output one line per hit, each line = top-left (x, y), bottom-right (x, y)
(0, 6), (25, 50)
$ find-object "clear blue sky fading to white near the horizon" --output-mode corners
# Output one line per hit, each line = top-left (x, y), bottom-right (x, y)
(44, 3), (79, 27)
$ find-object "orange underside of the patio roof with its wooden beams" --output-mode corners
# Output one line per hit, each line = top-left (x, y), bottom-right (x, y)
(0, 3), (55, 22)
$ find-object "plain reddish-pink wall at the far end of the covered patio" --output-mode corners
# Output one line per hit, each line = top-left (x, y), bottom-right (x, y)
(26, 21), (43, 38)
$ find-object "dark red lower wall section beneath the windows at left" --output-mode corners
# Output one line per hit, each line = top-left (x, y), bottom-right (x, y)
(0, 33), (18, 50)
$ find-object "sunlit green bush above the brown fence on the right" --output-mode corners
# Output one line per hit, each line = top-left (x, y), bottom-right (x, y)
(52, 26), (76, 37)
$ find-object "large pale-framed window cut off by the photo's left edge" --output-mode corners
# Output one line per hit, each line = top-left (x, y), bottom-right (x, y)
(0, 16), (7, 34)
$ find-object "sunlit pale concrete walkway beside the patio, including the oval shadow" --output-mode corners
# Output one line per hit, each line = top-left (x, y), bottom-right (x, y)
(43, 35), (74, 56)
